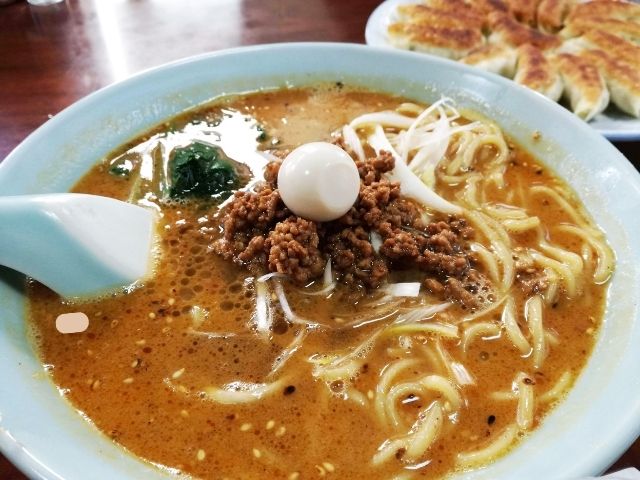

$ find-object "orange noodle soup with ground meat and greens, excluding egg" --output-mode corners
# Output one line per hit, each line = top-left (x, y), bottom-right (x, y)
(29, 85), (613, 479)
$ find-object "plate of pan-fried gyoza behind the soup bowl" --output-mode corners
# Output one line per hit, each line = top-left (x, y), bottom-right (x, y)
(366, 0), (640, 140)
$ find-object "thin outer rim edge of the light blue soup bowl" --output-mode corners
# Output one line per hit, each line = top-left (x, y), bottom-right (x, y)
(0, 42), (640, 478)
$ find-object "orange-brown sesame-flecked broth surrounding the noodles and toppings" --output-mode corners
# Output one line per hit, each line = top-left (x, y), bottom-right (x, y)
(29, 86), (607, 479)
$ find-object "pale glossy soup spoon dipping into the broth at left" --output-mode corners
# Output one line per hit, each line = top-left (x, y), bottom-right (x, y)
(0, 193), (155, 298)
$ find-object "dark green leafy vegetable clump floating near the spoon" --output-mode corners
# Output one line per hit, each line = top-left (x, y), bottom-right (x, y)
(169, 142), (238, 198)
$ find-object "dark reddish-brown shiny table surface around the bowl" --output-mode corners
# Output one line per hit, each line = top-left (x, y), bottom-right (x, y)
(0, 0), (640, 480)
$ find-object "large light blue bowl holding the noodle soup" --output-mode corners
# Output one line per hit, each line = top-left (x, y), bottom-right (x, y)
(0, 44), (640, 480)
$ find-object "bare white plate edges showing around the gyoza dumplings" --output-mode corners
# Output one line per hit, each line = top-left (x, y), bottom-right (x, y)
(364, 0), (640, 141)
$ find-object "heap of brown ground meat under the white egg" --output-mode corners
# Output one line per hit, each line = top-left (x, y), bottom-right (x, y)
(214, 152), (489, 308)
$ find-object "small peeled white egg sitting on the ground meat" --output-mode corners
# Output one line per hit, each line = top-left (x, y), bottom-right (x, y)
(278, 142), (360, 222)
